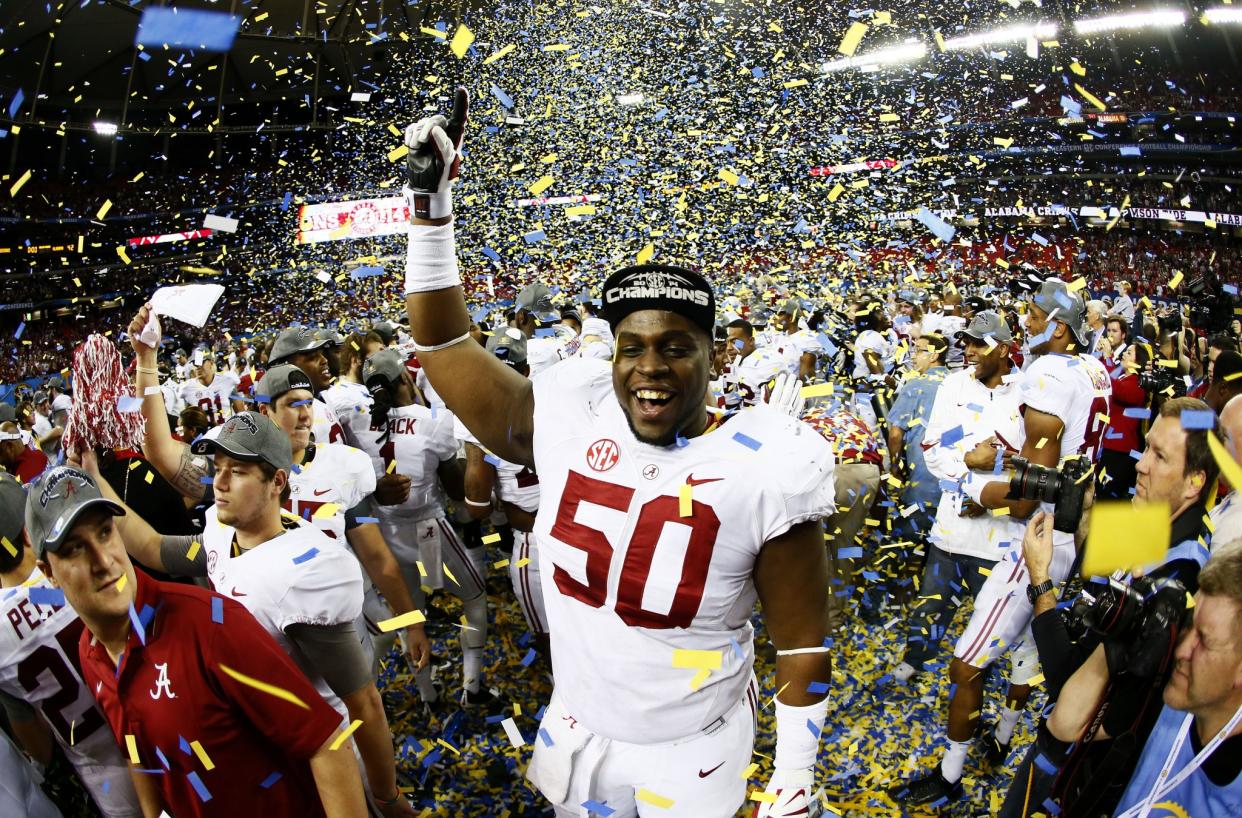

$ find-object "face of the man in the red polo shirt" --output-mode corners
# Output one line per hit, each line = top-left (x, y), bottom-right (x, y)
(40, 508), (137, 624)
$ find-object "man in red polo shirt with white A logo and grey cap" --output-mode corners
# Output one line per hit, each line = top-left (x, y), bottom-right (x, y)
(26, 467), (366, 818)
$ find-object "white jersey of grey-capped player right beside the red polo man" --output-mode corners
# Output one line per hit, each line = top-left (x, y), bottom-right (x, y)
(202, 505), (365, 715)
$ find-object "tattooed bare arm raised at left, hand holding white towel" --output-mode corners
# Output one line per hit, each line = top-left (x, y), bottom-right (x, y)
(128, 304), (209, 501)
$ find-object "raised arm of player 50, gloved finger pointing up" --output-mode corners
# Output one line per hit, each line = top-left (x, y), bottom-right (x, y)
(405, 88), (534, 465)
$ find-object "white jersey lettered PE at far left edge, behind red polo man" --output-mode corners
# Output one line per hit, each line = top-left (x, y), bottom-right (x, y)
(0, 569), (142, 817)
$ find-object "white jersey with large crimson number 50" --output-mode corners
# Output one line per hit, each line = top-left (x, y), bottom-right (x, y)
(533, 359), (836, 744)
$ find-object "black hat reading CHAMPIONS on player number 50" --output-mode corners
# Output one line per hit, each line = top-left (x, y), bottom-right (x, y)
(602, 264), (715, 338)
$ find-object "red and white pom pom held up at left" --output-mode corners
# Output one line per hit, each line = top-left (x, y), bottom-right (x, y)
(63, 335), (147, 452)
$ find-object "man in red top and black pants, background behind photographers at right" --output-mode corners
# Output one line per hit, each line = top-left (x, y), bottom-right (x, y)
(1095, 344), (1151, 500)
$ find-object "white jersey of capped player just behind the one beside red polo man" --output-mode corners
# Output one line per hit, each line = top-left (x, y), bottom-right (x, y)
(283, 443), (375, 545)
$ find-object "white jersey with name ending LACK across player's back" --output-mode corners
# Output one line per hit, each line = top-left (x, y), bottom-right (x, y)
(358, 403), (457, 520)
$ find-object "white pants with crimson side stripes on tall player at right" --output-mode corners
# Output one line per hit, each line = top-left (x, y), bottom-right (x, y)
(953, 535), (1074, 670)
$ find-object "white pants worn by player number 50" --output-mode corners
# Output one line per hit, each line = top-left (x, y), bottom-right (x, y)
(527, 676), (759, 818)
